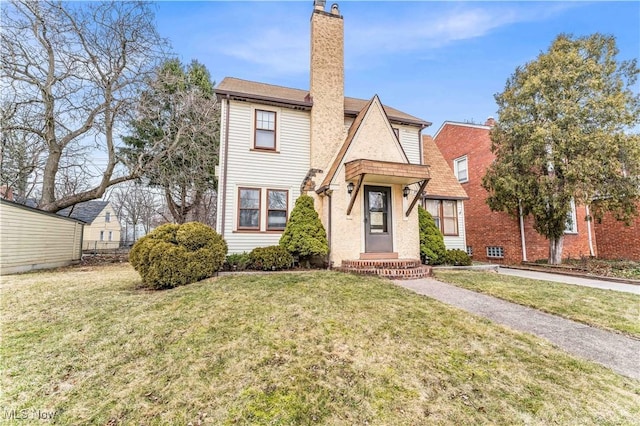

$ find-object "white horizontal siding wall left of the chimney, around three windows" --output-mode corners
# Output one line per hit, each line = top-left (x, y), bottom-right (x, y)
(216, 100), (310, 253)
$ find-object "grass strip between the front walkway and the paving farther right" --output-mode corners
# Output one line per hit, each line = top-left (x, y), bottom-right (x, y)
(436, 271), (640, 338)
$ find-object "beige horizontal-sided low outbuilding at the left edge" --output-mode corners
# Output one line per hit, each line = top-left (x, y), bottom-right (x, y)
(0, 201), (83, 275)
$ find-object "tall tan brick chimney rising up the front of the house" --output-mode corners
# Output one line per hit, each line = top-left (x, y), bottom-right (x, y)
(310, 0), (345, 171)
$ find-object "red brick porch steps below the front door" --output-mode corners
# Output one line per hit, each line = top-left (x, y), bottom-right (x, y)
(335, 259), (431, 280)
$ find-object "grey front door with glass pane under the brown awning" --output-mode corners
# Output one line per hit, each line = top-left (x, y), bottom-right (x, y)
(364, 185), (393, 253)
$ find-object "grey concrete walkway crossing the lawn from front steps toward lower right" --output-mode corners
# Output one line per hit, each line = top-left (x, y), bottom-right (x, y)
(394, 278), (640, 380)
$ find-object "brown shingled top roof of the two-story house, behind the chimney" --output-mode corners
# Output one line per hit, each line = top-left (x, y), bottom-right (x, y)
(216, 77), (431, 127)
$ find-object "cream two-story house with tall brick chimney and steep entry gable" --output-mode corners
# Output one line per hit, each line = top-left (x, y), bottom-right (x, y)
(216, 0), (462, 276)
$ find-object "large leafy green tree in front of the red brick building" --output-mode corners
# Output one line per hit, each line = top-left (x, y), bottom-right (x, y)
(483, 34), (640, 264)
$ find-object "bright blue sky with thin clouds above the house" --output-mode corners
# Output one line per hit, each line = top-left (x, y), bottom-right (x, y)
(156, 0), (640, 134)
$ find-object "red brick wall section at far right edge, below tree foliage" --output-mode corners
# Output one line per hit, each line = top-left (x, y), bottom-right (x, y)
(594, 209), (640, 261)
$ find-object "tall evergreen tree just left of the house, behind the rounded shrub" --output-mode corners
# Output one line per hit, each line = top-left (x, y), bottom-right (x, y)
(123, 59), (220, 223)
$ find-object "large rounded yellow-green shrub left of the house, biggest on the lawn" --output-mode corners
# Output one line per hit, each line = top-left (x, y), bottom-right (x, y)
(129, 222), (227, 289)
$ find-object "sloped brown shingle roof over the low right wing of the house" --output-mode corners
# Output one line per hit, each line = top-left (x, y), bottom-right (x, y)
(422, 135), (469, 200)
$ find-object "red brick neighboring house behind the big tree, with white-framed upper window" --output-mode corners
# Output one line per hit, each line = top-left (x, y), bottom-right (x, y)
(434, 118), (596, 264)
